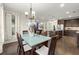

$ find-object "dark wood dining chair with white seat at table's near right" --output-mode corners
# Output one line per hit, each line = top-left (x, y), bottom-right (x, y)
(35, 35), (58, 55)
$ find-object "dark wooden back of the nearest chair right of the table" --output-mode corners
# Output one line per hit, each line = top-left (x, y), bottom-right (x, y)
(48, 35), (58, 55)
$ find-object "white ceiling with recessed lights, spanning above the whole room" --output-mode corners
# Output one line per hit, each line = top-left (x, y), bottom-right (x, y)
(4, 3), (79, 19)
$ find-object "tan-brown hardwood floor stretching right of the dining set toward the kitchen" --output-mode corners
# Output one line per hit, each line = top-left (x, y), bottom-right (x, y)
(55, 36), (79, 55)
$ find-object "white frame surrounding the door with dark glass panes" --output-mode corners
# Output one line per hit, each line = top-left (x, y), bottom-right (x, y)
(4, 11), (19, 44)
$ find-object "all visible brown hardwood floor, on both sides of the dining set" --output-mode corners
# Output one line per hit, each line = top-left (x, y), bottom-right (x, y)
(2, 36), (79, 55)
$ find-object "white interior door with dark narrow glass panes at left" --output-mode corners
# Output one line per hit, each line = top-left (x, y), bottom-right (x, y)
(5, 13), (17, 43)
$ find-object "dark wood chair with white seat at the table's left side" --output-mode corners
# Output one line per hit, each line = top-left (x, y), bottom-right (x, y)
(17, 34), (32, 55)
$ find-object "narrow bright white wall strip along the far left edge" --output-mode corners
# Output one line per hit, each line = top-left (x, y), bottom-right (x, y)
(0, 4), (4, 53)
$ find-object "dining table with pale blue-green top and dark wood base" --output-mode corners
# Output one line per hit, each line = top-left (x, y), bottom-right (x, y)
(22, 33), (51, 54)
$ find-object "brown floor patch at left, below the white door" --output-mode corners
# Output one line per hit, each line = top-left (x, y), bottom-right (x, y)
(2, 42), (18, 55)
